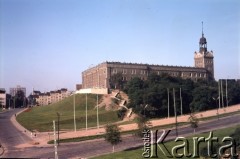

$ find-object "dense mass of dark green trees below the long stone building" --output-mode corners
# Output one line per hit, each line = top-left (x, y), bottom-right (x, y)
(124, 73), (240, 117)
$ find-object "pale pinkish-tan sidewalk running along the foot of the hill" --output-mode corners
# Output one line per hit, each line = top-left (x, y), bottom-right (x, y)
(11, 104), (240, 147)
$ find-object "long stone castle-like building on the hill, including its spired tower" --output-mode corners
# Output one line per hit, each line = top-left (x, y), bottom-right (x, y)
(82, 26), (214, 89)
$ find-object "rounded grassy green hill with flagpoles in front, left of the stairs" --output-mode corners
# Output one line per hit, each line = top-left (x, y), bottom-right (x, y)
(17, 94), (119, 131)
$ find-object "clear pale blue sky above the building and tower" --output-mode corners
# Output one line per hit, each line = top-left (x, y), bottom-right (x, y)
(0, 0), (240, 94)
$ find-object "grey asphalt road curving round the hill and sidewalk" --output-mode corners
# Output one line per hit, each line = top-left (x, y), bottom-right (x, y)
(0, 109), (240, 158)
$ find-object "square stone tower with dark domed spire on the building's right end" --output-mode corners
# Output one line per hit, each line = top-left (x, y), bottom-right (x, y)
(194, 22), (214, 79)
